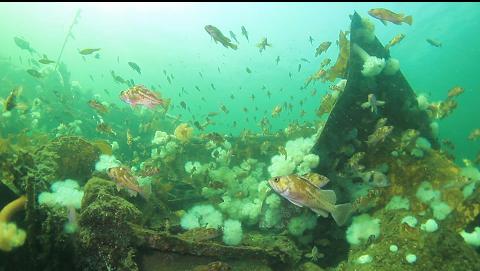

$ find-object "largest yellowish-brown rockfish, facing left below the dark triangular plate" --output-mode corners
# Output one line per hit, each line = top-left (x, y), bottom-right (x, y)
(268, 173), (353, 226)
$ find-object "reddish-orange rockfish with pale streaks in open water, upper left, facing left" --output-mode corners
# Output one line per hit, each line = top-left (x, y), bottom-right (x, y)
(120, 85), (170, 111)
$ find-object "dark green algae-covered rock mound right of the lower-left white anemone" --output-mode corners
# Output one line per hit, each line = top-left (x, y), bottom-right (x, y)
(78, 178), (142, 270)
